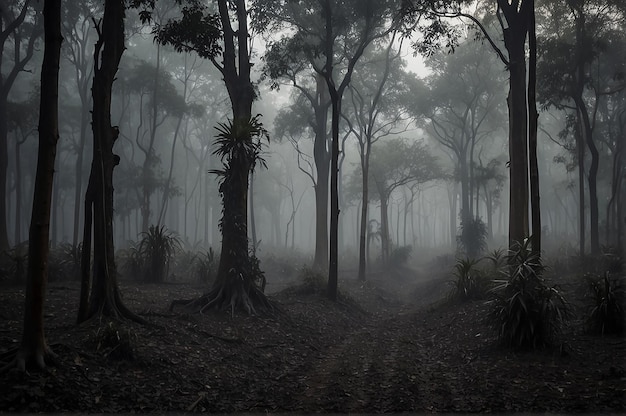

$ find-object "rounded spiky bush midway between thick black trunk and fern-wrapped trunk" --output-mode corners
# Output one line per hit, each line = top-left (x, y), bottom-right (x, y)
(139, 225), (180, 283)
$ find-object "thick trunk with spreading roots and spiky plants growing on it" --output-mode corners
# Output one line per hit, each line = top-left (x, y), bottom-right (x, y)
(170, 0), (274, 314)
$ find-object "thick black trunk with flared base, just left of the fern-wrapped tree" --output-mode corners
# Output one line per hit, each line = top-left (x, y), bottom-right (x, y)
(78, 0), (144, 322)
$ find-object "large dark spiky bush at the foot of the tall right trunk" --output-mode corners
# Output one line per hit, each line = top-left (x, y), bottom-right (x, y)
(490, 239), (570, 348)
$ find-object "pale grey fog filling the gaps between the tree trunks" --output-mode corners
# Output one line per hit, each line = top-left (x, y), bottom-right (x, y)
(2, 0), (624, 272)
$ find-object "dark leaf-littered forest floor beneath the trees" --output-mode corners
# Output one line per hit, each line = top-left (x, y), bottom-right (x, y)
(0, 264), (626, 414)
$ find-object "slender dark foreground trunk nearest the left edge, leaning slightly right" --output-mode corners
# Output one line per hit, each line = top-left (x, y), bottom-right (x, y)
(17, 0), (63, 369)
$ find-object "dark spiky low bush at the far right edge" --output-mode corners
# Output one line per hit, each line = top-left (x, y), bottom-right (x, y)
(585, 271), (626, 335)
